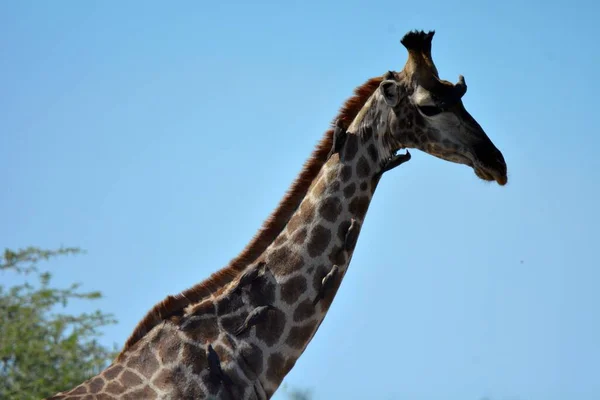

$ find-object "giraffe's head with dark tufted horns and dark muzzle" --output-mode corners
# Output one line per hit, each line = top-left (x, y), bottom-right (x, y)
(376, 31), (508, 185)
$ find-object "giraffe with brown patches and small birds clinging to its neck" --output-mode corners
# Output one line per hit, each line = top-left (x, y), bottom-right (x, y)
(50, 31), (508, 400)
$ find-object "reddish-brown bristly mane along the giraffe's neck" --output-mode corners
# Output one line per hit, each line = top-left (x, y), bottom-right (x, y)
(119, 77), (382, 356)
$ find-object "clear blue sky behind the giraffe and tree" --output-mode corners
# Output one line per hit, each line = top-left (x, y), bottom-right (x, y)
(0, 0), (600, 400)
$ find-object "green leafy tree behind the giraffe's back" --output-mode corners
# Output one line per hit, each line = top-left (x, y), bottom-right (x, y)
(0, 247), (116, 400)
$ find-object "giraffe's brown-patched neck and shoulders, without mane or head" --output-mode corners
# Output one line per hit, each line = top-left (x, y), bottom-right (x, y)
(48, 126), (394, 399)
